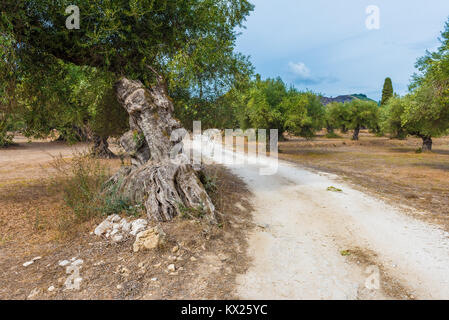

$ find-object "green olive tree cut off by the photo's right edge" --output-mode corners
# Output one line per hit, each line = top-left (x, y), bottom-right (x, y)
(382, 21), (449, 151)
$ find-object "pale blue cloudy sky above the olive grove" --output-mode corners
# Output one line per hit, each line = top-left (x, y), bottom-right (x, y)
(233, 0), (449, 100)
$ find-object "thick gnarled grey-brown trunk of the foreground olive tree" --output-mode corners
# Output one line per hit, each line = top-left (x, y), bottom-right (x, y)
(109, 78), (215, 222)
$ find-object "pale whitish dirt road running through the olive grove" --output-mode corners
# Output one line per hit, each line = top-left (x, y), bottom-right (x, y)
(201, 142), (449, 299)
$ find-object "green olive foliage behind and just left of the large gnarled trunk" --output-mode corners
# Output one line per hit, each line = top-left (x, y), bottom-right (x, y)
(18, 60), (128, 148)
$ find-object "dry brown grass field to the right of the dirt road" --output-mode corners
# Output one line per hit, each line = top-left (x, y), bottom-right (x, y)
(279, 131), (449, 230)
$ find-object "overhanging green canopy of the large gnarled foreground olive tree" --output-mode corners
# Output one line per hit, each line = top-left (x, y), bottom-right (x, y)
(0, 0), (253, 139)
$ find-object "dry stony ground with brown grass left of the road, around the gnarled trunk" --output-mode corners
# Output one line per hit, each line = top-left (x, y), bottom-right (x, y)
(0, 138), (252, 299)
